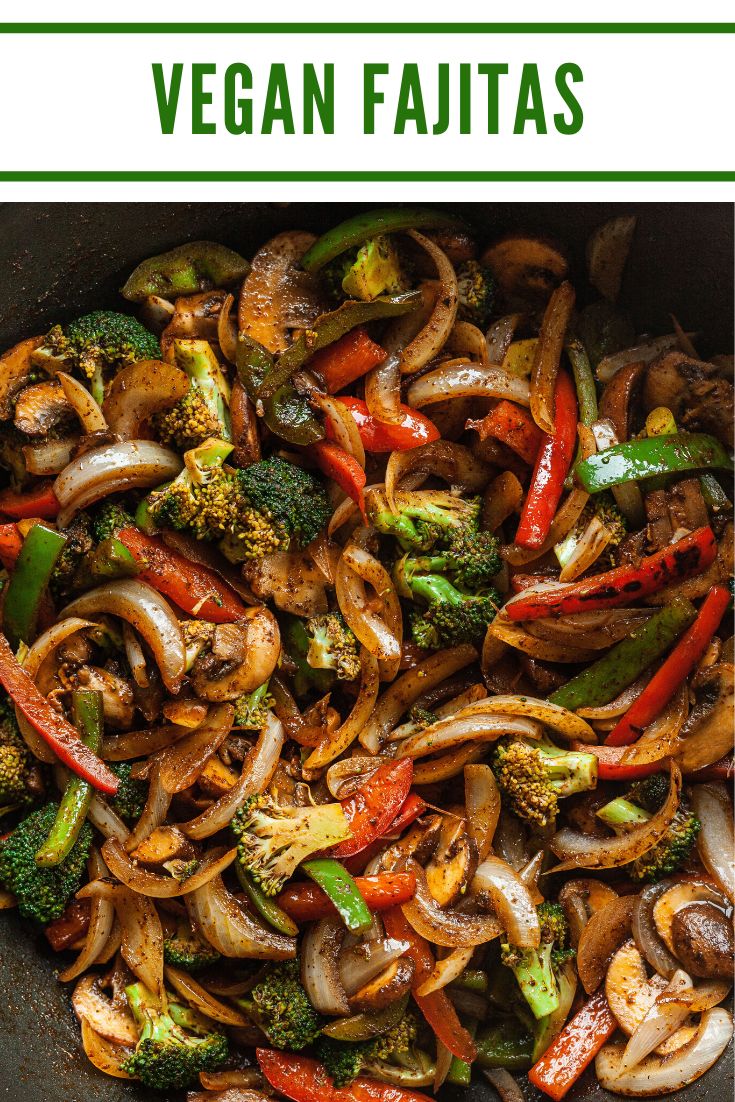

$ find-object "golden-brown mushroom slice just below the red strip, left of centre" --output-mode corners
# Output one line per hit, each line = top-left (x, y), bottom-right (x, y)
(191, 605), (281, 701)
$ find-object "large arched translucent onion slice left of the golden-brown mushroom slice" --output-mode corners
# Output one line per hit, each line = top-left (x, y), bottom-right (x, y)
(60, 579), (186, 693)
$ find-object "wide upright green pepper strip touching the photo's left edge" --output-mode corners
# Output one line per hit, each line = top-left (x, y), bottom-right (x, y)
(2, 525), (66, 647)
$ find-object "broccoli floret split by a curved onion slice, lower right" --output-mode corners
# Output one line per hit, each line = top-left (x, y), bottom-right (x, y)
(597, 774), (702, 882)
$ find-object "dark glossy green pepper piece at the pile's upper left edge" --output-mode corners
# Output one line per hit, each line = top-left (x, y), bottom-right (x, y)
(121, 241), (250, 302)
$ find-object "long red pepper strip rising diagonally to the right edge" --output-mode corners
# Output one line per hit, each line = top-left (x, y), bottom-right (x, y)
(605, 586), (731, 746)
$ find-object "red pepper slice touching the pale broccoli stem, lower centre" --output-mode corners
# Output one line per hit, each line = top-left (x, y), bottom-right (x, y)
(329, 758), (413, 857)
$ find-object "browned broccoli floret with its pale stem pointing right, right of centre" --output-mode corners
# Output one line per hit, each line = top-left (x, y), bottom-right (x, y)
(491, 738), (597, 827)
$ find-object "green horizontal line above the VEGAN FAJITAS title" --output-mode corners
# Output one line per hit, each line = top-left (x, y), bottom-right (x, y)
(0, 23), (735, 34)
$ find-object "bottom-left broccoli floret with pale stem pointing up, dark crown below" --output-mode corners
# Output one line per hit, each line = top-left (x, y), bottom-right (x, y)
(120, 983), (229, 1091)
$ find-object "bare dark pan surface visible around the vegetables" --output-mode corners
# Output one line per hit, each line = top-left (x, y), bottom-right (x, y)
(0, 203), (733, 1102)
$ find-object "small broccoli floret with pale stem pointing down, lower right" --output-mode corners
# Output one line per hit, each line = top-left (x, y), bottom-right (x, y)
(500, 903), (573, 1019)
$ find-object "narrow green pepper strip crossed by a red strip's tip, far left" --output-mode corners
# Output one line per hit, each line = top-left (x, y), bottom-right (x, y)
(35, 689), (105, 868)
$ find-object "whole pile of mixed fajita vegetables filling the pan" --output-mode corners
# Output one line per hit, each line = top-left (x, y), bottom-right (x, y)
(0, 208), (735, 1102)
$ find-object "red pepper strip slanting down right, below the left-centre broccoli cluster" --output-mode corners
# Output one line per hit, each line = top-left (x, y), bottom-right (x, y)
(117, 528), (247, 624)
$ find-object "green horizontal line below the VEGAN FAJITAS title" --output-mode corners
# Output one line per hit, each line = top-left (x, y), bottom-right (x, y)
(5, 170), (735, 183)
